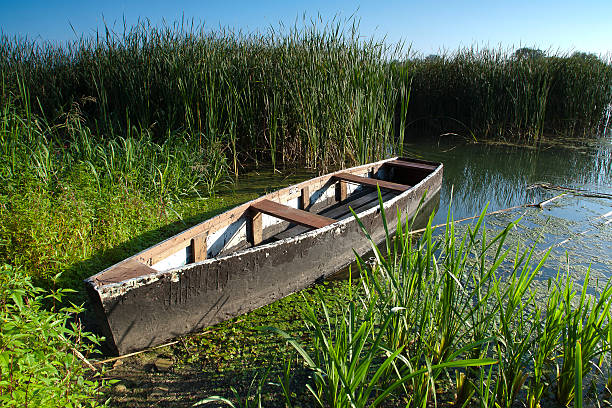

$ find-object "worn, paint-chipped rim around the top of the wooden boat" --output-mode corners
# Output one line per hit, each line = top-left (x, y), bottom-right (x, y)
(85, 156), (443, 296)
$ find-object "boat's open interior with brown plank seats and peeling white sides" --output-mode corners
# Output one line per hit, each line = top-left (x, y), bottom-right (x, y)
(91, 158), (438, 286)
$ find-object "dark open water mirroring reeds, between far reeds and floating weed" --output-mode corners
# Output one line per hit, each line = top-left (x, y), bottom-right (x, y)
(405, 139), (612, 221)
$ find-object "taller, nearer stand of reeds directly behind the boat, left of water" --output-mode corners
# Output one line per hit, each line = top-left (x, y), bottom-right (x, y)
(0, 16), (402, 173)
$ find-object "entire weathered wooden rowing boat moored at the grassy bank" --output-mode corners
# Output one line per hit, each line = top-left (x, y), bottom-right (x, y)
(85, 158), (442, 354)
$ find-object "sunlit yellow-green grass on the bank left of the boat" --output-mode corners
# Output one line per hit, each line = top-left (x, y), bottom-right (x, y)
(0, 81), (230, 289)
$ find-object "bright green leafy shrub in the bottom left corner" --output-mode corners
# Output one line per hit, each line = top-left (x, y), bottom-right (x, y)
(0, 265), (107, 407)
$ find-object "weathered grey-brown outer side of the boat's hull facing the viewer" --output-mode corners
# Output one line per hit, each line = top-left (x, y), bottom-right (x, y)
(86, 157), (442, 354)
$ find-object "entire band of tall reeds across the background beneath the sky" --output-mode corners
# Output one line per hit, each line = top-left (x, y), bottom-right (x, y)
(0, 19), (612, 174)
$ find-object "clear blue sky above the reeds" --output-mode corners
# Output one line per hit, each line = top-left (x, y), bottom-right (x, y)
(0, 0), (612, 55)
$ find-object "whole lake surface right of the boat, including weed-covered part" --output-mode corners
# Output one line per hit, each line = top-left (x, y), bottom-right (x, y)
(404, 137), (612, 281)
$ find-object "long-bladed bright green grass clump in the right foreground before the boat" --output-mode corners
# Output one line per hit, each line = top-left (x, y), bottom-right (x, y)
(192, 196), (612, 408)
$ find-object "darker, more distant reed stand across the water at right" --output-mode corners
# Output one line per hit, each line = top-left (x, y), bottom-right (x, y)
(399, 47), (612, 142)
